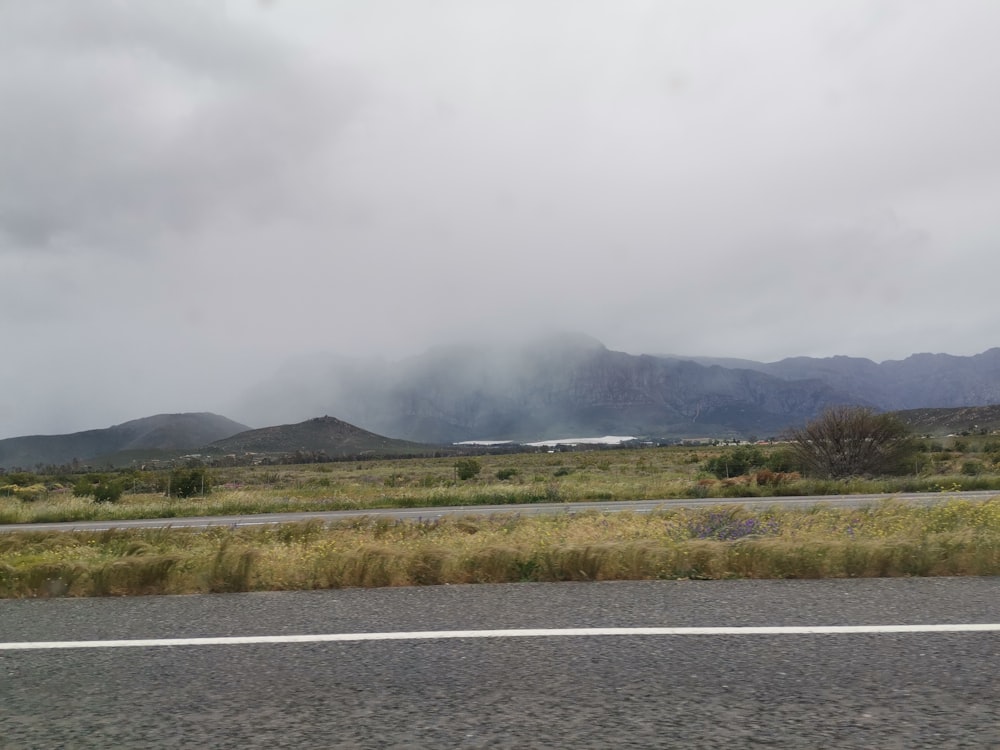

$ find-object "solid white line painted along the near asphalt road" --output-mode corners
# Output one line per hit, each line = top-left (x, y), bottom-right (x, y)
(0, 623), (1000, 651)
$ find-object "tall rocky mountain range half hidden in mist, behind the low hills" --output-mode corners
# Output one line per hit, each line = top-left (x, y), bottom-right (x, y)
(236, 335), (1000, 443)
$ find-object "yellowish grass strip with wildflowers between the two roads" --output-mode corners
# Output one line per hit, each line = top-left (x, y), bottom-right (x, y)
(0, 499), (1000, 597)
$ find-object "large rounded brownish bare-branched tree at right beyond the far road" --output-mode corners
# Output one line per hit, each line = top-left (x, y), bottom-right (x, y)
(788, 406), (916, 479)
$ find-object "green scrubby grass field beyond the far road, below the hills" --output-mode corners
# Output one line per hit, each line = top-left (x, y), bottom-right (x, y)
(0, 447), (1000, 523)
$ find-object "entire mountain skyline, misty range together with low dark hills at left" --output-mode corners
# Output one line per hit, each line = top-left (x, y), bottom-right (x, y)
(0, 335), (1000, 468)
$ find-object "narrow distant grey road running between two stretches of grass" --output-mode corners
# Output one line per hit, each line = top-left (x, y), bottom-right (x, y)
(0, 490), (1000, 533)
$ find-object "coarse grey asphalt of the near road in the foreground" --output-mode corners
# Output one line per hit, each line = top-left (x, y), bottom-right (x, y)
(0, 578), (1000, 748)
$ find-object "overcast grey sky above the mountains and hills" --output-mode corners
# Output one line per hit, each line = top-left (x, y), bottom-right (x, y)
(0, 0), (1000, 437)
